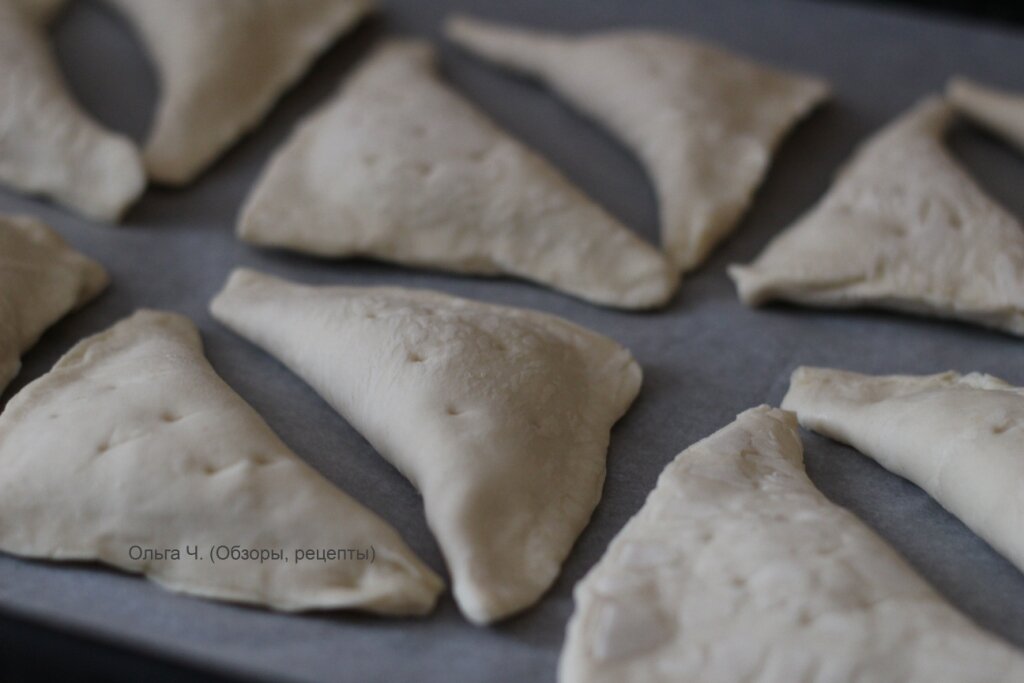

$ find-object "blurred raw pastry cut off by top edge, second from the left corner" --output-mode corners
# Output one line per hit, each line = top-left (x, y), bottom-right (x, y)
(109, 0), (372, 185)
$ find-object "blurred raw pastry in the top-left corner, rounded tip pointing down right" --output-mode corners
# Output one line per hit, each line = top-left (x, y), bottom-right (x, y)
(0, 0), (145, 221)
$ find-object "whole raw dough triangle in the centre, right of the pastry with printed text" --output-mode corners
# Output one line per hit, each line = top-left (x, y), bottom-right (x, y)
(212, 270), (641, 624)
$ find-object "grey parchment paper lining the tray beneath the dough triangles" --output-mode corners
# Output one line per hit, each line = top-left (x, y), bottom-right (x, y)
(0, 0), (1024, 682)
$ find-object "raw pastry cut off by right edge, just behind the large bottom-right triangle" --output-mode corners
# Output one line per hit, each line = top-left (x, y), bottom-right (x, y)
(782, 368), (1024, 570)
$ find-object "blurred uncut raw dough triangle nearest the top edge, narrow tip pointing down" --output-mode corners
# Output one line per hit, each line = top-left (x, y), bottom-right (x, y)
(447, 17), (828, 271)
